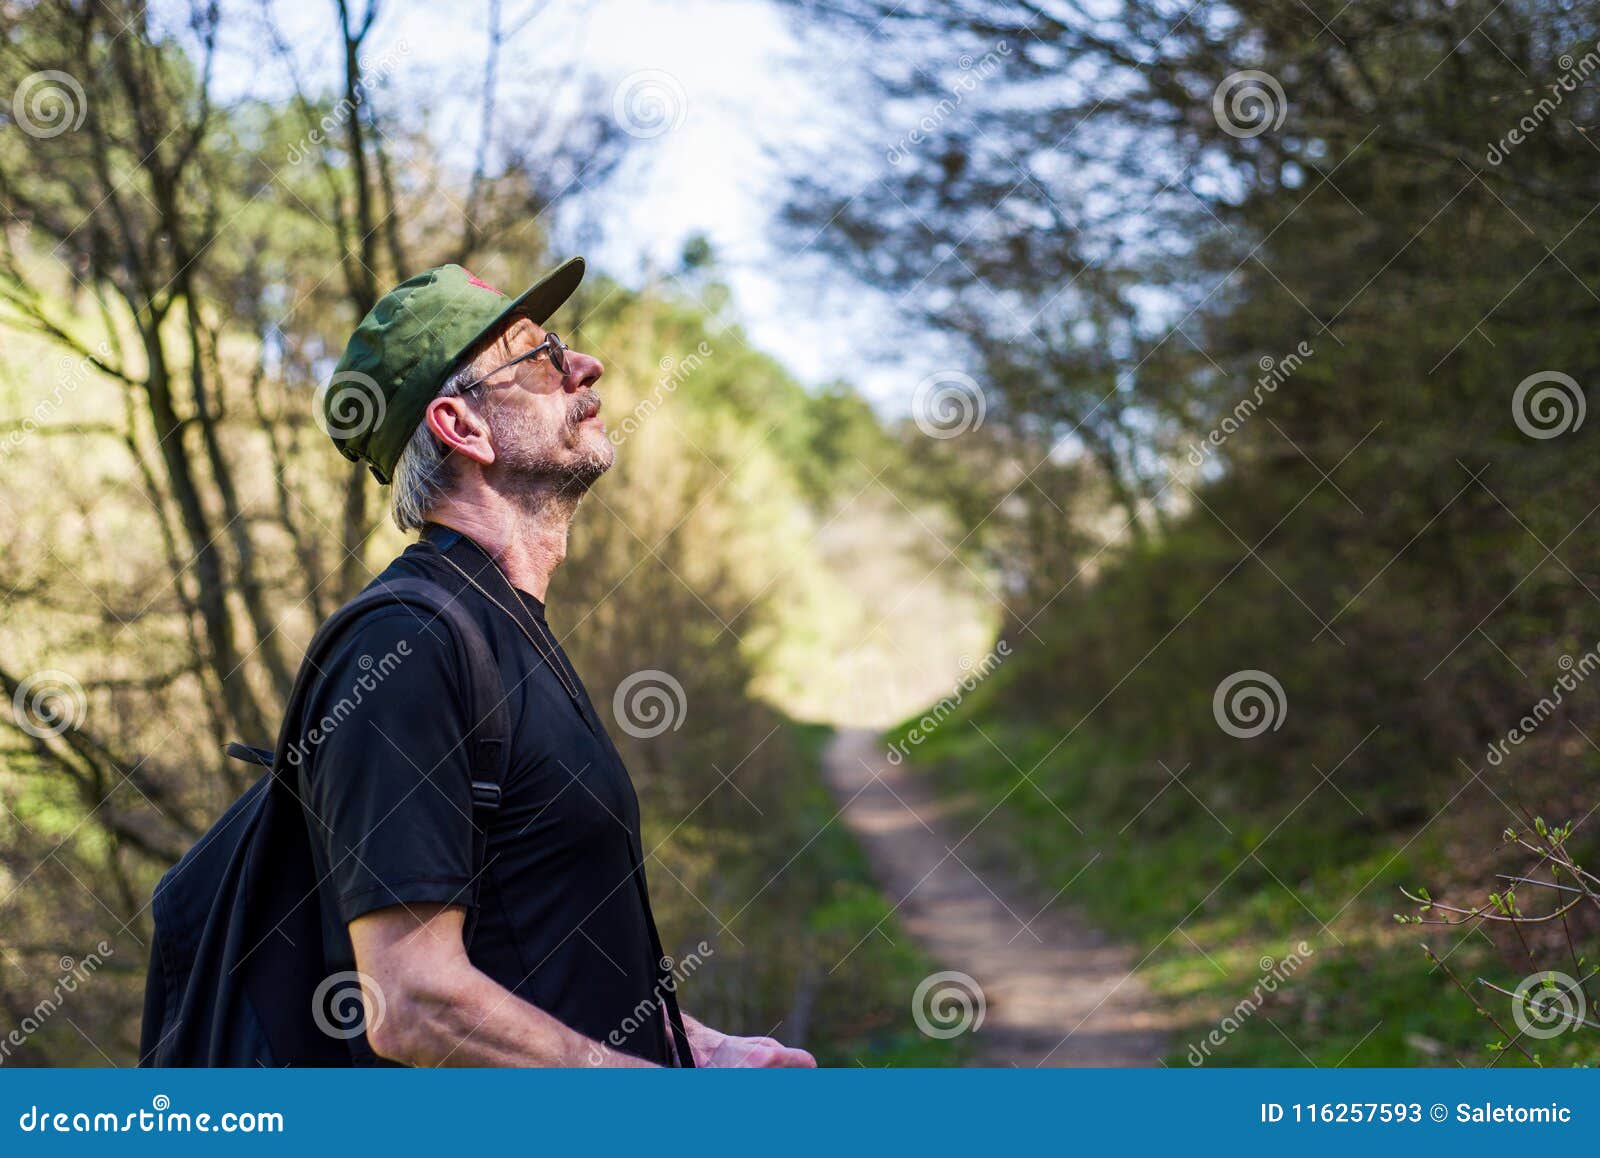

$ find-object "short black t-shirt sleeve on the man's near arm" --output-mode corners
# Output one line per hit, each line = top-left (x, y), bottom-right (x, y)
(299, 606), (474, 923)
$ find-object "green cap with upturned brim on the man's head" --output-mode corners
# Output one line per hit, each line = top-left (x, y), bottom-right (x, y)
(317, 258), (584, 485)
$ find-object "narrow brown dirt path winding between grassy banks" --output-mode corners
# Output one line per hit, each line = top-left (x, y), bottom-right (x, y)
(824, 729), (1163, 1065)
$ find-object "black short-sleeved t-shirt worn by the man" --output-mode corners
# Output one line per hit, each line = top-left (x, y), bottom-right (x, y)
(298, 526), (672, 1065)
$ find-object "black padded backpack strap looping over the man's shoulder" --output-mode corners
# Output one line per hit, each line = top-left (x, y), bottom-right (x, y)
(276, 579), (510, 939)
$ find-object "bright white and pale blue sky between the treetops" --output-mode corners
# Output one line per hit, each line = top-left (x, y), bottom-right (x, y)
(206, 0), (941, 407)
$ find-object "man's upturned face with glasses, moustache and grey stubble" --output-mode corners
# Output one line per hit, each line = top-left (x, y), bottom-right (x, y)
(478, 320), (616, 497)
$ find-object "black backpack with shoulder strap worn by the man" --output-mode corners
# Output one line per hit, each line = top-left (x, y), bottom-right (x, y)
(139, 579), (510, 1065)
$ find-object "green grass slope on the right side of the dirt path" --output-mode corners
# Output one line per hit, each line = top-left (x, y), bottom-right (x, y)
(899, 722), (1595, 1067)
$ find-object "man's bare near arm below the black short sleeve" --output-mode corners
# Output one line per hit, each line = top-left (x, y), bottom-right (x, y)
(349, 904), (650, 1067)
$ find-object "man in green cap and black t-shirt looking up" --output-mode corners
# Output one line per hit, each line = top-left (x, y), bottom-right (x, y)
(307, 258), (816, 1067)
